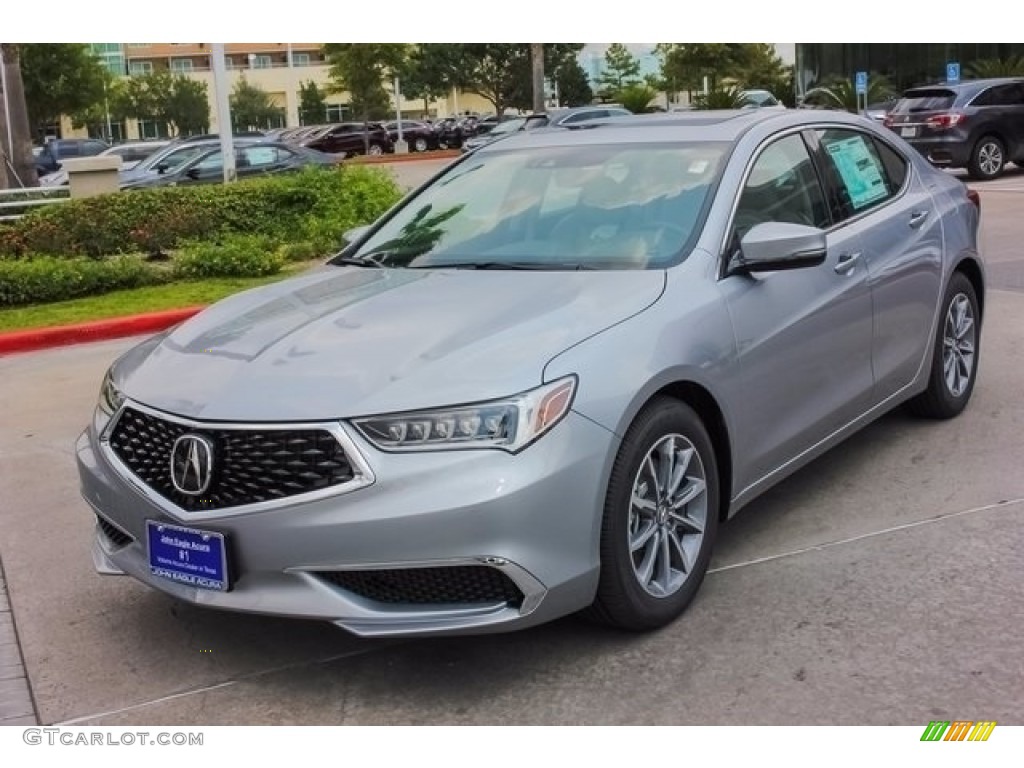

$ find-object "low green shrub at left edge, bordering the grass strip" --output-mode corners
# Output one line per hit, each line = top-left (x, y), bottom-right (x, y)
(0, 256), (166, 306)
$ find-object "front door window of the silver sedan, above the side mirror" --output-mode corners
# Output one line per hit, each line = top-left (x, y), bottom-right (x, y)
(733, 134), (830, 240)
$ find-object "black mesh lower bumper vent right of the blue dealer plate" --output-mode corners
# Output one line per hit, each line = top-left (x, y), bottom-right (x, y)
(316, 565), (522, 607)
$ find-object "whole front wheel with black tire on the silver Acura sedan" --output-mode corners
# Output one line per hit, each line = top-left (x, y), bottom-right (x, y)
(585, 397), (720, 632)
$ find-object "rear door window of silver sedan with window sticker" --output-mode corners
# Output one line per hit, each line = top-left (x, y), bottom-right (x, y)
(817, 128), (906, 217)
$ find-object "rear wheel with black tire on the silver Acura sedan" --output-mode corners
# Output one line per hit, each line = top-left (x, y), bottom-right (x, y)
(908, 272), (981, 419)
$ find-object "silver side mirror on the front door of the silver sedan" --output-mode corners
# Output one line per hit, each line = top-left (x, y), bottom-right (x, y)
(729, 221), (828, 274)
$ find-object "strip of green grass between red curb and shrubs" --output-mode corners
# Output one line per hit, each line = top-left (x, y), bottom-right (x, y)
(0, 261), (311, 332)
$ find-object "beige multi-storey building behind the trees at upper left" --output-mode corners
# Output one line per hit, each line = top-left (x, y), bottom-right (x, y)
(61, 43), (492, 140)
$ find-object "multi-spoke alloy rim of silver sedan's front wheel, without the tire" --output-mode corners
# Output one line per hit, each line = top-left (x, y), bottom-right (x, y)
(627, 434), (708, 597)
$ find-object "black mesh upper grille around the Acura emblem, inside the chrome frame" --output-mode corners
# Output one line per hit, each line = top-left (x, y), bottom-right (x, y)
(111, 408), (354, 511)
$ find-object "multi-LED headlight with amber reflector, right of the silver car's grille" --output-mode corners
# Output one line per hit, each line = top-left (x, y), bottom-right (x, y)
(354, 376), (577, 454)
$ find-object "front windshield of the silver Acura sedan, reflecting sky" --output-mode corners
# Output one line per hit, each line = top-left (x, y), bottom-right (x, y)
(339, 142), (728, 269)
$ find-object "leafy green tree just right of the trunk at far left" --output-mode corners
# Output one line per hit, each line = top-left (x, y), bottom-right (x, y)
(18, 43), (106, 140)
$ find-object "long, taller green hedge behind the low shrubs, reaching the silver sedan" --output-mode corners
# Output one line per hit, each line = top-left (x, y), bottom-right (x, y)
(0, 166), (401, 259)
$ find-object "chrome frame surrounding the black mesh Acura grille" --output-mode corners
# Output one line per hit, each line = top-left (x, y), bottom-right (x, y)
(98, 398), (377, 521)
